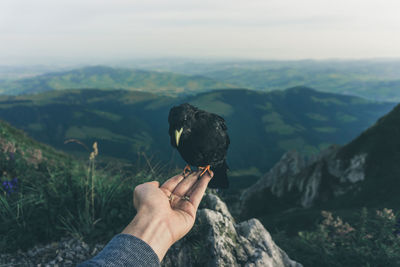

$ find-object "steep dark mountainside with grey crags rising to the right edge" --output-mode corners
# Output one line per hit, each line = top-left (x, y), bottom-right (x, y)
(240, 105), (400, 222)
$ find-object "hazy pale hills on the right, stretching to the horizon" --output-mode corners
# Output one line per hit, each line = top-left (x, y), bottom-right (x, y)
(120, 59), (400, 102)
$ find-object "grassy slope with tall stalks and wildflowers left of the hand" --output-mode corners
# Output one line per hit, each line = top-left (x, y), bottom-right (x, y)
(0, 121), (164, 251)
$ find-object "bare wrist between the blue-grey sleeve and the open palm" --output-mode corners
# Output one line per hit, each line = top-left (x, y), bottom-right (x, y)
(122, 212), (173, 262)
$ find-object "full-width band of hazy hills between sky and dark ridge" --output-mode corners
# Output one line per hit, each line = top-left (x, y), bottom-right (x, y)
(0, 59), (400, 102)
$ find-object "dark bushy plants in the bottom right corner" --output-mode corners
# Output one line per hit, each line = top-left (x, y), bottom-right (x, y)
(274, 208), (400, 266)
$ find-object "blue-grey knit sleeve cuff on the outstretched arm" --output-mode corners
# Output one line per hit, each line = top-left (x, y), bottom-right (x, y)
(77, 234), (160, 267)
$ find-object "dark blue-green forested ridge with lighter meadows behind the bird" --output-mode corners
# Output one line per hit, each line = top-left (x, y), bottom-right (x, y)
(0, 87), (393, 177)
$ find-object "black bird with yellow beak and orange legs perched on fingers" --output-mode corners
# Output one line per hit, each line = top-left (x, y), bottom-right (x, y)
(168, 103), (230, 188)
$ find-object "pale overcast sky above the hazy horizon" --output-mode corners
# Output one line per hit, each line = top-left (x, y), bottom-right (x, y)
(0, 0), (400, 65)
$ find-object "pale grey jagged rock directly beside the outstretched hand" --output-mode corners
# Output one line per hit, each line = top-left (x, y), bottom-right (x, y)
(162, 194), (302, 267)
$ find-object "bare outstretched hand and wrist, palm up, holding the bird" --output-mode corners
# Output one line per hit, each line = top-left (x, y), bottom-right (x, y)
(122, 172), (213, 262)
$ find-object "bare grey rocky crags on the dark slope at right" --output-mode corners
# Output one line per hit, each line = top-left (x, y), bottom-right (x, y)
(241, 146), (367, 208)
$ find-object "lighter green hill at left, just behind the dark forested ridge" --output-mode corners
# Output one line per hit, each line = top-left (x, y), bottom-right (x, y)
(0, 66), (233, 95)
